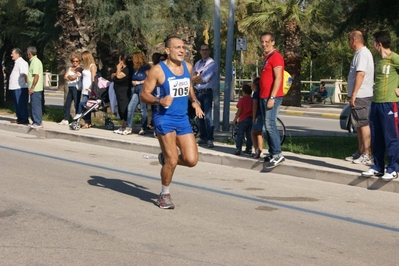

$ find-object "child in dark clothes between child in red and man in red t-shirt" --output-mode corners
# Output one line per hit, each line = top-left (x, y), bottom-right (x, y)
(251, 78), (264, 158)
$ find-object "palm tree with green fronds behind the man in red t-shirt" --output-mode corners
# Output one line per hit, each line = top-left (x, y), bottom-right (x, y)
(239, 0), (312, 106)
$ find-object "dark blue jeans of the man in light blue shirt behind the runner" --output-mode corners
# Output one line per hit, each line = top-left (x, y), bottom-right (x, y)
(195, 90), (214, 140)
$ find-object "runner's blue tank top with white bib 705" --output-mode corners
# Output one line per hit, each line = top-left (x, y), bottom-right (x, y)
(154, 61), (190, 117)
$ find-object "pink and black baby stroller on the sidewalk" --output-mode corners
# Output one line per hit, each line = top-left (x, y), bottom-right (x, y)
(69, 77), (115, 130)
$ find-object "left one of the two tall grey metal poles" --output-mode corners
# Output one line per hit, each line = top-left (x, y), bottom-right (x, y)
(213, 0), (220, 131)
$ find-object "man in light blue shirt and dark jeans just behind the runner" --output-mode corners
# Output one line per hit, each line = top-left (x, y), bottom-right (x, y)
(192, 44), (218, 148)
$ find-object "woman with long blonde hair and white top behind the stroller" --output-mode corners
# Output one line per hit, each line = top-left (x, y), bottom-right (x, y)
(74, 51), (97, 129)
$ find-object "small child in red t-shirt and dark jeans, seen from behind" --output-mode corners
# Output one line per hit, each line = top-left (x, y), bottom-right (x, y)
(233, 84), (252, 155)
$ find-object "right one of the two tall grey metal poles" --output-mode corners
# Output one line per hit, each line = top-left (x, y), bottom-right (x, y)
(222, 0), (236, 131)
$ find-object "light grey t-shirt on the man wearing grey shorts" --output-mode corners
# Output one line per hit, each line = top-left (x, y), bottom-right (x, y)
(348, 46), (374, 98)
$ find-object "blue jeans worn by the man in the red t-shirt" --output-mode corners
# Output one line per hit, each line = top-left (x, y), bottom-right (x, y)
(260, 97), (283, 158)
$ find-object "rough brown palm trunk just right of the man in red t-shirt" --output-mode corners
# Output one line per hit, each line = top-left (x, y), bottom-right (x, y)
(282, 20), (302, 106)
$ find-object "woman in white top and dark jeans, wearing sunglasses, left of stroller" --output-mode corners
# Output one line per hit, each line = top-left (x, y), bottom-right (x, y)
(58, 55), (82, 125)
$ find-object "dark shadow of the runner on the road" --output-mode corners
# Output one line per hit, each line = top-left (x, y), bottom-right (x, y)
(87, 176), (158, 204)
